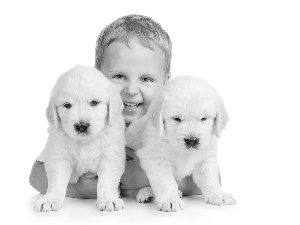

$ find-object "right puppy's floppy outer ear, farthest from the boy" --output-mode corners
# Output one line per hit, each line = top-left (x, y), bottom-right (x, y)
(215, 94), (229, 138)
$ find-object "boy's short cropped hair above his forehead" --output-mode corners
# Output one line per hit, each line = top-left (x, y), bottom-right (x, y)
(95, 14), (172, 76)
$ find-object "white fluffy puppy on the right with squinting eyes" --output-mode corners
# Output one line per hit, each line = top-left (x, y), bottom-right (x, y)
(126, 76), (236, 211)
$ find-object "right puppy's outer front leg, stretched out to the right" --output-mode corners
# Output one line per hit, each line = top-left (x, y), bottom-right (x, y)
(192, 157), (236, 205)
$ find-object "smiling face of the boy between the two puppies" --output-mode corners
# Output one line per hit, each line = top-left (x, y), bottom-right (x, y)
(100, 38), (165, 123)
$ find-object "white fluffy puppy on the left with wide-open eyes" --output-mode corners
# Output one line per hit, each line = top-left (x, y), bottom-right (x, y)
(35, 65), (125, 212)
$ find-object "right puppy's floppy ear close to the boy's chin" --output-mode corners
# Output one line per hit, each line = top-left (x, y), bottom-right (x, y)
(148, 95), (164, 136)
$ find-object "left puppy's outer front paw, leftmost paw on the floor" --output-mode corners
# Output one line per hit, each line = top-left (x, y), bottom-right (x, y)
(34, 195), (63, 212)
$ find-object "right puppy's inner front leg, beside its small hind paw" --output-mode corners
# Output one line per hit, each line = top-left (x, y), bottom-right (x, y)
(141, 160), (184, 212)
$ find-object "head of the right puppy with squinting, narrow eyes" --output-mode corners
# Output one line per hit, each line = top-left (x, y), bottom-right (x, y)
(149, 76), (228, 151)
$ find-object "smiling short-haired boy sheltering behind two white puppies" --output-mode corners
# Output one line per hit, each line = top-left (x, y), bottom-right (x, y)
(30, 15), (201, 198)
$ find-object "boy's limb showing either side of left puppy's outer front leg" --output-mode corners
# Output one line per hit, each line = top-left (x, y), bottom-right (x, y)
(29, 161), (98, 199)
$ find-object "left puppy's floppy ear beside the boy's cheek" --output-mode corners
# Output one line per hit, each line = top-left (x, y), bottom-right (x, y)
(108, 91), (124, 126)
